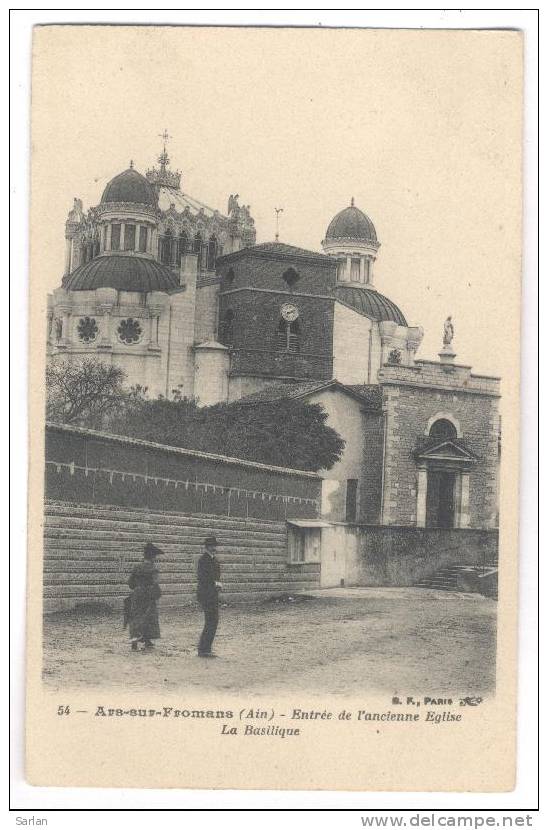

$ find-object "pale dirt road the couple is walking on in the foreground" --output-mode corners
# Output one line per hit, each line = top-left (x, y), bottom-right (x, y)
(44, 588), (497, 696)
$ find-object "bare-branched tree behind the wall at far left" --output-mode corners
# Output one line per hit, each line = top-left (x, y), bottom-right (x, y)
(46, 359), (125, 426)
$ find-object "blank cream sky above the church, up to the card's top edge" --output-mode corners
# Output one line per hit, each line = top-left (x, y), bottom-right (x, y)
(31, 26), (521, 375)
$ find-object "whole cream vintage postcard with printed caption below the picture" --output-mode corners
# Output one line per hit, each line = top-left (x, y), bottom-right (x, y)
(27, 25), (522, 792)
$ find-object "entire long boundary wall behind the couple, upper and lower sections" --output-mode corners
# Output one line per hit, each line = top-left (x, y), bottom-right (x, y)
(44, 424), (321, 614)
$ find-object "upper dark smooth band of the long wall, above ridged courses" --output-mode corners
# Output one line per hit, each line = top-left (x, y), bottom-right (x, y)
(45, 424), (321, 521)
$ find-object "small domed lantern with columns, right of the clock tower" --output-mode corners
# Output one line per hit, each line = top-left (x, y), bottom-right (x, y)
(322, 202), (380, 288)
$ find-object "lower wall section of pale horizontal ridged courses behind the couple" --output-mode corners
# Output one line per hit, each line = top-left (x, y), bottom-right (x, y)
(44, 501), (320, 613)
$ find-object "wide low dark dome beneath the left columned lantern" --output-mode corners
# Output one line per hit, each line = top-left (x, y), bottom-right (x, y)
(63, 254), (179, 293)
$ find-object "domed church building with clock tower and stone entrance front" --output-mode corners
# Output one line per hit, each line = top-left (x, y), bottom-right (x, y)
(48, 145), (500, 528)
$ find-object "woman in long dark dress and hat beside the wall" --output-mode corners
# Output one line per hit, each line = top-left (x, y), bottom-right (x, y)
(127, 542), (163, 651)
